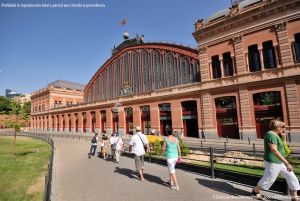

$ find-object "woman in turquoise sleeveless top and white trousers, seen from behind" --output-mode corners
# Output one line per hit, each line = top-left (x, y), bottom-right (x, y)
(162, 128), (180, 190)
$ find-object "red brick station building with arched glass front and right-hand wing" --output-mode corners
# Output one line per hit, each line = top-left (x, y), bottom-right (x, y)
(32, 0), (300, 142)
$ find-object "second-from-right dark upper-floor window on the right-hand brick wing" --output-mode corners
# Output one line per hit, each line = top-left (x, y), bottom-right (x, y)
(263, 40), (277, 69)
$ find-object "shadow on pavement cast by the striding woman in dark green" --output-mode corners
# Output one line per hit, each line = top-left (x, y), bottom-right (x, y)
(196, 179), (251, 196)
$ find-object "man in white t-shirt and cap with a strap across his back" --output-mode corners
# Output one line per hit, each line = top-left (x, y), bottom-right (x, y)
(129, 126), (149, 181)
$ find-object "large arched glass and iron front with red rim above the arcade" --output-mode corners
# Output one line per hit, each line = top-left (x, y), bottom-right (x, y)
(84, 38), (200, 102)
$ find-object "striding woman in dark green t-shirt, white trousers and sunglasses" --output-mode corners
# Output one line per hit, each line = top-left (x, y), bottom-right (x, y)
(252, 120), (300, 201)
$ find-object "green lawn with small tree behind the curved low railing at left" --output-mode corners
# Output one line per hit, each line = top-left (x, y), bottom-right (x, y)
(0, 137), (51, 201)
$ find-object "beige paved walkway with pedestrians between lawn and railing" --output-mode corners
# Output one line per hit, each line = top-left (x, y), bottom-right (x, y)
(51, 138), (292, 201)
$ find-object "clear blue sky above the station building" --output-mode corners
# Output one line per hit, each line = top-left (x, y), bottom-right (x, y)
(0, 0), (231, 95)
